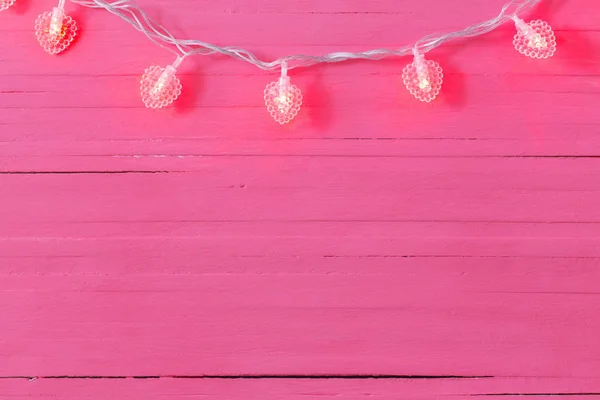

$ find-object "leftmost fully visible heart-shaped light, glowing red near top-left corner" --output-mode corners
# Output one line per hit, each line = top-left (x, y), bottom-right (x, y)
(35, 0), (77, 54)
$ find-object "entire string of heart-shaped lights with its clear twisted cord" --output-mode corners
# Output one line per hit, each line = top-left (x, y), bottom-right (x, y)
(0, 0), (556, 124)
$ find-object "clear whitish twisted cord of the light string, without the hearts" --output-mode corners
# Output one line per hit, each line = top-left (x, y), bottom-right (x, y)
(71, 0), (541, 71)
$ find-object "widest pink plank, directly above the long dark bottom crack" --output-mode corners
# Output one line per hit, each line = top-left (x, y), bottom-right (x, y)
(0, 268), (600, 377)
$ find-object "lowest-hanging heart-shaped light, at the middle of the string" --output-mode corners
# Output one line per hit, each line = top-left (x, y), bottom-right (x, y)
(264, 62), (302, 124)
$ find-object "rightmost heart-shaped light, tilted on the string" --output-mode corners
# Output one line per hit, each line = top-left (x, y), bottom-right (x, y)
(513, 16), (556, 58)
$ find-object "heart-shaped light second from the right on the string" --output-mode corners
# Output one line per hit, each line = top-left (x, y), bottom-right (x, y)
(402, 47), (444, 102)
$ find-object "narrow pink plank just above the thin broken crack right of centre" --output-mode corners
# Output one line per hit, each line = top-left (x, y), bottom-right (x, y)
(0, 234), (599, 260)
